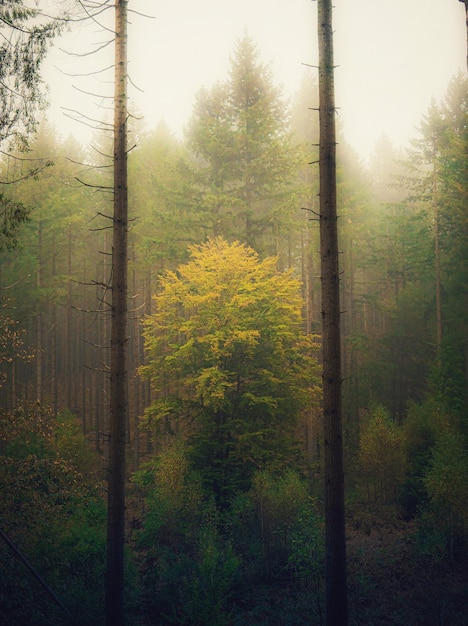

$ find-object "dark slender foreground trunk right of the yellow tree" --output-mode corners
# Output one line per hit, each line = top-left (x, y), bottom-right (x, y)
(318, 0), (348, 626)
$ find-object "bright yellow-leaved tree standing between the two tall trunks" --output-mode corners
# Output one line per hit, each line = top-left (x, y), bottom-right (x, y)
(142, 238), (318, 503)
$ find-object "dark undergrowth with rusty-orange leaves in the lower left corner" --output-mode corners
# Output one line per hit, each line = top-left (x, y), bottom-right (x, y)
(0, 404), (106, 626)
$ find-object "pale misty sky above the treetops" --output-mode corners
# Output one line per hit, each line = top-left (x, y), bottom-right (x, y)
(45, 0), (466, 158)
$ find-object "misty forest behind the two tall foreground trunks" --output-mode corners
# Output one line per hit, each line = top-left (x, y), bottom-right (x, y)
(0, 13), (468, 626)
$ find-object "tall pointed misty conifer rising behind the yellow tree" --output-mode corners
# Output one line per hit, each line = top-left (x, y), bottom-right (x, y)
(188, 36), (297, 253)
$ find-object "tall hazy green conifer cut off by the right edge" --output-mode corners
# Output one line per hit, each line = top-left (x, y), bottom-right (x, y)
(395, 75), (468, 407)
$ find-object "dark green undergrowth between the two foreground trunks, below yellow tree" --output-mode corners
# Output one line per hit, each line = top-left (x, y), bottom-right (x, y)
(134, 456), (323, 626)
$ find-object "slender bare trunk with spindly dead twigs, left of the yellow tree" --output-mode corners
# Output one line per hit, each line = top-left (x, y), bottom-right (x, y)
(106, 0), (128, 626)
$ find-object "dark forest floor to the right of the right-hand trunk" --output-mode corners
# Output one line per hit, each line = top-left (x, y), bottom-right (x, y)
(347, 522), (468, 626)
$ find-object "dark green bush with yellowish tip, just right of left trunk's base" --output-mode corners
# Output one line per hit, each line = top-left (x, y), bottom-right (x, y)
(134, 442), (239, 626)
